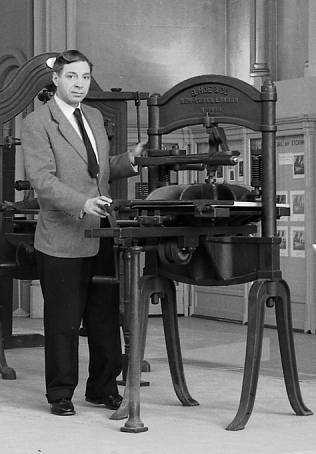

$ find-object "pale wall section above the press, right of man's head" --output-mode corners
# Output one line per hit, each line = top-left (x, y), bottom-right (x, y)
(77, 0), (225, 94)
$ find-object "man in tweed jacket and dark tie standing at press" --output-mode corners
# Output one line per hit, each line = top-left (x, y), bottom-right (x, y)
(21, 50), (146, 416)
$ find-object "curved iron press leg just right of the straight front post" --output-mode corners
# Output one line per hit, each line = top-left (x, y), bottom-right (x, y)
(162, 277), (199, 407)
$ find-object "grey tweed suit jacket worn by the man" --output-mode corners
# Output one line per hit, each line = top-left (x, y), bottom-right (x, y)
(21, 99), (135, 258)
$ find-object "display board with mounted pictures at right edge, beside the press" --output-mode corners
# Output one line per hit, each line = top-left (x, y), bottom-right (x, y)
(266, 116), (316, 333)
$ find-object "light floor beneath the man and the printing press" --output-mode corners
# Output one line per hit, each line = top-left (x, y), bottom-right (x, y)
(0, 317), (316, 454)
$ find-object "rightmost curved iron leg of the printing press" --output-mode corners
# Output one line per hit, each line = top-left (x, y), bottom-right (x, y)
(275, 280), (313, 416)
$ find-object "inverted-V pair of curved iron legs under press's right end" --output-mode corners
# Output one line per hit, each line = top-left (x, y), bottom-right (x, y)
(227, 280), (312, 430)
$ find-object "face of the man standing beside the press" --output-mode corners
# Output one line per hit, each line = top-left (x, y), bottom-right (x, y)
(53, 61), (91, 107)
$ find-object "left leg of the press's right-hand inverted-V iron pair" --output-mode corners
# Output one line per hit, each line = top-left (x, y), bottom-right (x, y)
(227, 281), (269, 430)
